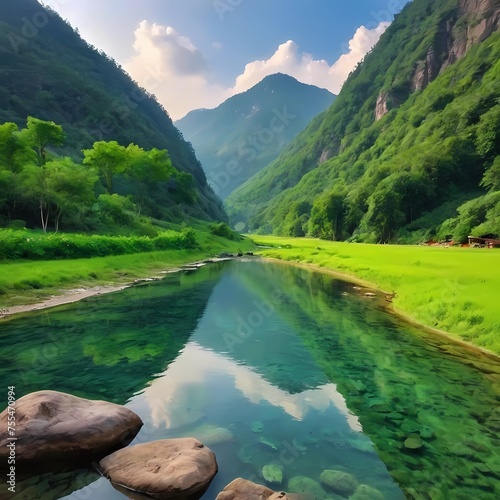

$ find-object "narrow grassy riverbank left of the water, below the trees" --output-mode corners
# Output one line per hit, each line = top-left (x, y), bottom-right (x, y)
(0, 231), (253, 310)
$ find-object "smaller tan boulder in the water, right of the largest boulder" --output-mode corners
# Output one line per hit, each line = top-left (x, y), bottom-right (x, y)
(99, 438), (217, 500)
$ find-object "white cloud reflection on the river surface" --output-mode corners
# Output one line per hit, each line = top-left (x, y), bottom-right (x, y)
(128, 342), (363, 432)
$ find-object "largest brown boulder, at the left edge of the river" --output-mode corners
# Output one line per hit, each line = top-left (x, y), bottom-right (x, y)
(0, 391), (143, 463)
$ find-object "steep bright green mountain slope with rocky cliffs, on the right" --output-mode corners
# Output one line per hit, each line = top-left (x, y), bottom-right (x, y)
(227, 0), (500, 242)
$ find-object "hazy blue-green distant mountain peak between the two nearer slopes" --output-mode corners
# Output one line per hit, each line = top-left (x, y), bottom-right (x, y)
(175, 74), (335, 198)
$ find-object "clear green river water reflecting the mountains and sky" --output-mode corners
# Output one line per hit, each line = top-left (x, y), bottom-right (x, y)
(0, 261), (500, 500)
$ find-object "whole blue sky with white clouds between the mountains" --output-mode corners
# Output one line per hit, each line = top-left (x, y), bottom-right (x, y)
(45, 0), (408, 119)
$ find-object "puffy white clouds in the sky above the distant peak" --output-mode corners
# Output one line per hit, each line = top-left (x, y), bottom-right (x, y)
(124, 21), (389, 119)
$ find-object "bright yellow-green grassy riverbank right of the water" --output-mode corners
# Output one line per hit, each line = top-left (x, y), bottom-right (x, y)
(256, 236), (500, 354)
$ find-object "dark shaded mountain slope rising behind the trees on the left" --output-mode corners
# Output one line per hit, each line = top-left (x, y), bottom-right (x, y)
(0, 0), (226, 220)
